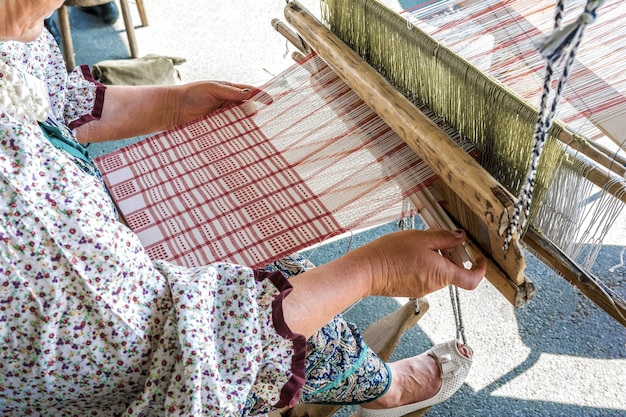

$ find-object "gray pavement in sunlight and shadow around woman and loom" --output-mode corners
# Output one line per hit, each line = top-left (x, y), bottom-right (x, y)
(57, 0), (626, 417)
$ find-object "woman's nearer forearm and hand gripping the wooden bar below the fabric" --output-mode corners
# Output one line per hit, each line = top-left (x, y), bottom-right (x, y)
(283, 230), (487, 337)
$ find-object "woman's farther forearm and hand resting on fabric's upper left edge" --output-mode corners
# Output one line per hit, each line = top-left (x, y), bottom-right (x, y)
(76, 81), (256, 143)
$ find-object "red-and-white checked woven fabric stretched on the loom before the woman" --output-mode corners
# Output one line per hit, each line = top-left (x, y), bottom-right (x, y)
(96, 56), (448, 267)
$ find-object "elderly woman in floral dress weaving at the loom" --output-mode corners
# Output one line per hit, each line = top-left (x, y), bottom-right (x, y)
(0, 0), (485, 416)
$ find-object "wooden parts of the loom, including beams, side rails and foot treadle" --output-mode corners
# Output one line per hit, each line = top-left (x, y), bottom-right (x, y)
(264, 0), (626, 417)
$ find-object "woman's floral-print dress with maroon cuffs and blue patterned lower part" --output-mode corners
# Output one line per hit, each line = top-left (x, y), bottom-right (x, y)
(0, 31), (390, 417)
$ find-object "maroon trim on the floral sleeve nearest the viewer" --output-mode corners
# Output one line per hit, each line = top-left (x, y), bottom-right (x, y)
(254, 270), (306, 408)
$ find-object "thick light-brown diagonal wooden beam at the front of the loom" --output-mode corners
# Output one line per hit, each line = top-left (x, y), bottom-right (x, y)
(285, 2), (527, 300)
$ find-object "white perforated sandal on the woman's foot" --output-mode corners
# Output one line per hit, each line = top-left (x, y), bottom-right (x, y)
(360, 340), (473, 417)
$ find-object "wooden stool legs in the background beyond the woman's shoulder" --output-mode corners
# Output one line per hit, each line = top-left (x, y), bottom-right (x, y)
(57, 0), (148, 71)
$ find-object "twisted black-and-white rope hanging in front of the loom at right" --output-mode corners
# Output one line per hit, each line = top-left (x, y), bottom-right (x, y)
(503, 0), (605, 253)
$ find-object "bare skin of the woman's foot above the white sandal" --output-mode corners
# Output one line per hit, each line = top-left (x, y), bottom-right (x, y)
(361, 344), (471, 409)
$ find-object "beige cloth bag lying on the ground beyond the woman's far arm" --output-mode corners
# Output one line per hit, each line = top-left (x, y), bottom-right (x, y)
(91, 55), (186, 85)
